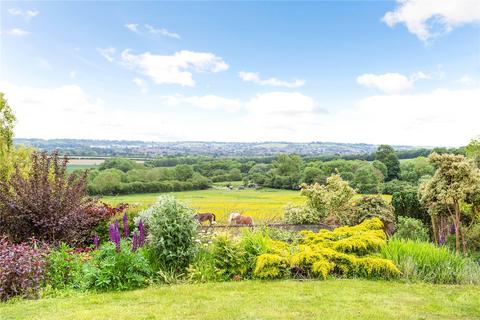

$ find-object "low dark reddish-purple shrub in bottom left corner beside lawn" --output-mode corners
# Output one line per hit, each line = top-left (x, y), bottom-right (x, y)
(0, 238), (46, 300)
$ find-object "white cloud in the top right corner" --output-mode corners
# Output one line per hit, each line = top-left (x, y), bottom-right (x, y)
(382, 0), (480, 42)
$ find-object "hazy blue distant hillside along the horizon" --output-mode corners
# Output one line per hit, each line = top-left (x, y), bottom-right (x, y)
(15, 139), (432, 157)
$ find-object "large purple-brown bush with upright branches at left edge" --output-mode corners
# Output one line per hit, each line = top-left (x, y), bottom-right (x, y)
(0, 152), (106, 244)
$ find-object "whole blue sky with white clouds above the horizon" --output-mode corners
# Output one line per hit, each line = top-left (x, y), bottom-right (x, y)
(0, 0), (480, 146)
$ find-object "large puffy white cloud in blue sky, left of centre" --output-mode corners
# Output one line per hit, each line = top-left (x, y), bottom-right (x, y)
(121, 49), (228, 87)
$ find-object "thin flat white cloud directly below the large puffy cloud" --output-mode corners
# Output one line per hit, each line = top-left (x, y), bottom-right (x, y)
(162, 95), (242, 111)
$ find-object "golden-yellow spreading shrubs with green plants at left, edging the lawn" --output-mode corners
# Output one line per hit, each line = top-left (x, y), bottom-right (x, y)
(189, 219), (400, 280)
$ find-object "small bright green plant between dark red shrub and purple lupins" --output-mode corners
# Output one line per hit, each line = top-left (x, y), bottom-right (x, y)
(45, 244), (89, 289)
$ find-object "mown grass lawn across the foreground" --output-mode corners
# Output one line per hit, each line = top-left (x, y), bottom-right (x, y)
(0, 280), (480, 320)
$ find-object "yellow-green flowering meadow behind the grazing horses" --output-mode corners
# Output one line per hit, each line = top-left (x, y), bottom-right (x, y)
(103, 188), (390, 222)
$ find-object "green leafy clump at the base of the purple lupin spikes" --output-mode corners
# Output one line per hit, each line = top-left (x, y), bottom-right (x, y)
(83, 240), (152, 291)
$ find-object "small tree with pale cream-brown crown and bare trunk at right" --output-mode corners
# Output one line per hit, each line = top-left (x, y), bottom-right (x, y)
(420, 153), (480, 252)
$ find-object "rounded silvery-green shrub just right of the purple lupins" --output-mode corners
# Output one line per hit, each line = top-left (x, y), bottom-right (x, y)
(136, 196), (197, 269)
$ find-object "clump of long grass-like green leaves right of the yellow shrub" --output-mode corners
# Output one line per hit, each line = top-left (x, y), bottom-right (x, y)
(381, 239), (480, 284)
